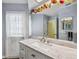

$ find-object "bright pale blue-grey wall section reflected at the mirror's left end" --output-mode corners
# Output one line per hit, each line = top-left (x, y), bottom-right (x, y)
(31, 14), (43, 36)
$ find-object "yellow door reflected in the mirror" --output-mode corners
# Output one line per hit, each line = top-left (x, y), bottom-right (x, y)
(48, 19), (57, 38)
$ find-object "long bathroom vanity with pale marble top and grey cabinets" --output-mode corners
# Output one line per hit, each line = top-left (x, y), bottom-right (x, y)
(19, 39), (77, 59)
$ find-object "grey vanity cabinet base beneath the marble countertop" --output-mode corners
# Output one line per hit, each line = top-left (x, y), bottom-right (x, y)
(20, 44), (53, 59)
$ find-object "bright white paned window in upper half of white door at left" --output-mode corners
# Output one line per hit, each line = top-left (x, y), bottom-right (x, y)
(6, 13), (26, 37)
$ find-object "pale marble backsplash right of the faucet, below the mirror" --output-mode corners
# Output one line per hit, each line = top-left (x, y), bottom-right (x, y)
(47, 38), (77, 49)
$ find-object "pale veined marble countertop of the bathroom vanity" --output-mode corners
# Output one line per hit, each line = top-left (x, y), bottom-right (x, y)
(20, 39), (77, 59)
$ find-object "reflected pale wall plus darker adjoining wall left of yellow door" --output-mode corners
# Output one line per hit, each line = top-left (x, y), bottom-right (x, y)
(31, 14), (48, 36)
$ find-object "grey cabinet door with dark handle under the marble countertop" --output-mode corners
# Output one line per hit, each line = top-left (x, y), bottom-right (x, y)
(28, 48), (45, 59)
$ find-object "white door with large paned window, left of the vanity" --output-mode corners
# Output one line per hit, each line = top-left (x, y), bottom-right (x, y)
(6, 12), (28, 58)
